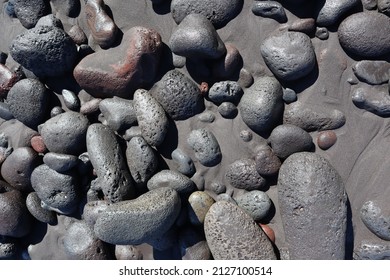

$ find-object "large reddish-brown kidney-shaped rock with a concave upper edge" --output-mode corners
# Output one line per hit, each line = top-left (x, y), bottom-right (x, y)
(73, 26), (163, 98)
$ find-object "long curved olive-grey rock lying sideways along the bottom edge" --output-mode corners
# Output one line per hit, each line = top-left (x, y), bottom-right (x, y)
(94, 188), (181, 245)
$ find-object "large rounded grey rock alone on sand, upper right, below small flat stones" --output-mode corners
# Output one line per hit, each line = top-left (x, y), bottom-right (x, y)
(260, 31), (316, 81)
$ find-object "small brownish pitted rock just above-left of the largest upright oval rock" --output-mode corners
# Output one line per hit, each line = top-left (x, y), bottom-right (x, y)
(255, 146), (282, 176)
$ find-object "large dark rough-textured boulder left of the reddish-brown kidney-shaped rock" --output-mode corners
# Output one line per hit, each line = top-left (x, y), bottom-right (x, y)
(10, 26), (77, 77)
